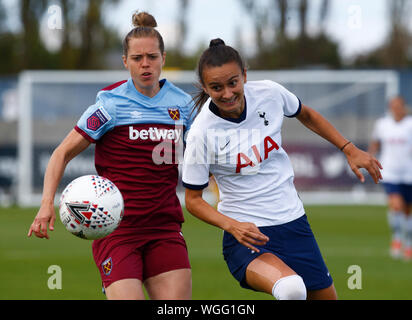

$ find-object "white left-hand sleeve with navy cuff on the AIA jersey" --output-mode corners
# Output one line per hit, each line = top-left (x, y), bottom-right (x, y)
(182, 131), (210, 190)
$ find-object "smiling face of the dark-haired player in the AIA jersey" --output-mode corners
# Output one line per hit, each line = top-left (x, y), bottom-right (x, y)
(202, 62), (246, 118)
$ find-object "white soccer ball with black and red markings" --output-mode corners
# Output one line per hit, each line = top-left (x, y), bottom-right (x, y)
(59, 175), (124, 240)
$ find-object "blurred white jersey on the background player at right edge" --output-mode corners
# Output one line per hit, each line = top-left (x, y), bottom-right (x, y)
(372, 116), (412, 184)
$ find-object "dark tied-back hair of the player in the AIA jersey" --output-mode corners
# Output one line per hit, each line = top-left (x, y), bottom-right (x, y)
(193, 38), (246, 114)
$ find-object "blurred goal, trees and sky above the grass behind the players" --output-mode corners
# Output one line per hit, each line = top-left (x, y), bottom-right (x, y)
(0, 0), (412, 205)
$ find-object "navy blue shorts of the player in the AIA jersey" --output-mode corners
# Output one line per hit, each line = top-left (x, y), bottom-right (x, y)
(223, 214), (333, 290)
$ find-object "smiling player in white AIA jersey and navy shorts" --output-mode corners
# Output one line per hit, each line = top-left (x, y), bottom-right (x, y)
(183, 39), (381, 300)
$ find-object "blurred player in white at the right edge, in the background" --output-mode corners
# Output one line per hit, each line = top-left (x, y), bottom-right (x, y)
(369, 97), (412, 260)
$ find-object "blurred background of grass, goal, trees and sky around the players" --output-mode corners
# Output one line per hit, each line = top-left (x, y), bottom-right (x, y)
(0, 0), (412, 299)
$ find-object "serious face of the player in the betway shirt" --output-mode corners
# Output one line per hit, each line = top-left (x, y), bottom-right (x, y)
(123, 37), (166, 97)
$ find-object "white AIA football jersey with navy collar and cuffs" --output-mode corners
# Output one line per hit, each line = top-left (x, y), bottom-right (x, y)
(182, 80), (304, 226)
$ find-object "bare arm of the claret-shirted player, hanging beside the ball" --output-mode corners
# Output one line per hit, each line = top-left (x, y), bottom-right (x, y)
(28, 129), (90, 239)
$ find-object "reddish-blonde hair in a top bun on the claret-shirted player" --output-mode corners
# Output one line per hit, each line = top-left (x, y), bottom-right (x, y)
(123, 11), (165, 57)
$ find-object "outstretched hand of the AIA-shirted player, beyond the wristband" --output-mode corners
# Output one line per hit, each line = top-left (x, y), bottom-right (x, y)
(343, 143), (383, 183)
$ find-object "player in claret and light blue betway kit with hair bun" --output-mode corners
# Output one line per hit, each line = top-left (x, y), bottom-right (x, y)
(28, 12), (193, 299)
